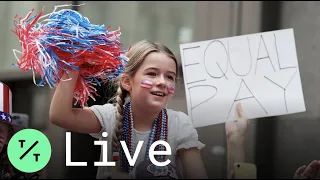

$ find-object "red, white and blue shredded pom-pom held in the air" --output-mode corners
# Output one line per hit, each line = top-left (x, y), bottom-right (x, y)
(12, 6), (128, 107)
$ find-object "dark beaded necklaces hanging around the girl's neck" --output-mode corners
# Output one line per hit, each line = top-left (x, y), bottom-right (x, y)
(119, 102), (168, 172)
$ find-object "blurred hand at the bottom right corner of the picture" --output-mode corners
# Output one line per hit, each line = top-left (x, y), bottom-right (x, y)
(293, 160), (320, 179)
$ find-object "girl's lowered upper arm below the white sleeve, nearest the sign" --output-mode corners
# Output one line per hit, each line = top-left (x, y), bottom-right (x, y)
(178, 148), (208, 179)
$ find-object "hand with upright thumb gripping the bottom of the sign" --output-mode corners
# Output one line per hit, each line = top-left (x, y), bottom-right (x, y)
(225, 103), (249, 142)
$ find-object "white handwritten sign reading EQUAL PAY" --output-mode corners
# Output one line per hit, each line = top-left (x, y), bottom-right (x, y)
(180, 29), (306, 127)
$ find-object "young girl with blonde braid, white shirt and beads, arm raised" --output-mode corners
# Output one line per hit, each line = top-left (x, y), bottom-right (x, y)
(50, 41), (248, 179)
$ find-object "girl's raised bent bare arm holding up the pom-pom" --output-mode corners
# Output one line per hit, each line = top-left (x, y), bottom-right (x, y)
(49, 71), (101, 133)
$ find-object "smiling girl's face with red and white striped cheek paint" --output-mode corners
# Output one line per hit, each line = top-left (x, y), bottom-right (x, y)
(124, 52), (176, 110)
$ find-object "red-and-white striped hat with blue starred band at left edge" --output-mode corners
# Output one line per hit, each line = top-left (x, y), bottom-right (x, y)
(0, 82), (12, 123)
